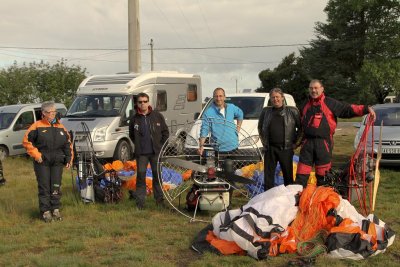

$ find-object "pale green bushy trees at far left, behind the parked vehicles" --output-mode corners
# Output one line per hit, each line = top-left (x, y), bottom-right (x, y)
(0, 59), (86, 106)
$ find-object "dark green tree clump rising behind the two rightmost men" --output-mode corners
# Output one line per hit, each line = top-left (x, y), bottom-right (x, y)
(257, 0), (400, 104)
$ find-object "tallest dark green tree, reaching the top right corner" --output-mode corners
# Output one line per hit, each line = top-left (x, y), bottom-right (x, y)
(300, 0), (400, 101)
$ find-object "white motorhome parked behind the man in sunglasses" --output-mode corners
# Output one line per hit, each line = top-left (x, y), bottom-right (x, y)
(62, 72), (202, 161)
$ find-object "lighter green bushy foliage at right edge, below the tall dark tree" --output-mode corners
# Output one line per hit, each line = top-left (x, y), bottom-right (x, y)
(357, 59), (400, 103)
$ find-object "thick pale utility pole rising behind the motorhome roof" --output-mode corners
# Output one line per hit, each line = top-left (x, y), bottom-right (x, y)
(128, 0), (141, 73)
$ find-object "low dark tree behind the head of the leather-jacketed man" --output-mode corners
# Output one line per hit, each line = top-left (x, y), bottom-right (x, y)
(257, 53), (309, 102)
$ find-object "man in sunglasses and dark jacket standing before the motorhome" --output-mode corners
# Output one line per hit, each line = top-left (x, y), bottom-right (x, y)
(129, 93), (169, 209)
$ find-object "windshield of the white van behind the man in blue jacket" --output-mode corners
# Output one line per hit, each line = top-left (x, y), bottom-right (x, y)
(203, 96), (265, 120)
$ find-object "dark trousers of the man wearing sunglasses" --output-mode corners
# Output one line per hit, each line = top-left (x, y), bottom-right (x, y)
(136, 154), (164, 206)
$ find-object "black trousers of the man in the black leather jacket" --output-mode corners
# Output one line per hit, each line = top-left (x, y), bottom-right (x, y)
(264, 146), (294, 191)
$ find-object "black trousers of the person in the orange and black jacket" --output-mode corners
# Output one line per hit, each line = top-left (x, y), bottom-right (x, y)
(33, 161), (64, 213)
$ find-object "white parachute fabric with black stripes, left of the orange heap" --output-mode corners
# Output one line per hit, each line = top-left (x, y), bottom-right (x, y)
(212, 185), (302, 259)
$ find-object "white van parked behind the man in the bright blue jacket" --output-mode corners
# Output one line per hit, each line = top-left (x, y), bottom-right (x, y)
(185, 93), (296, 153)
